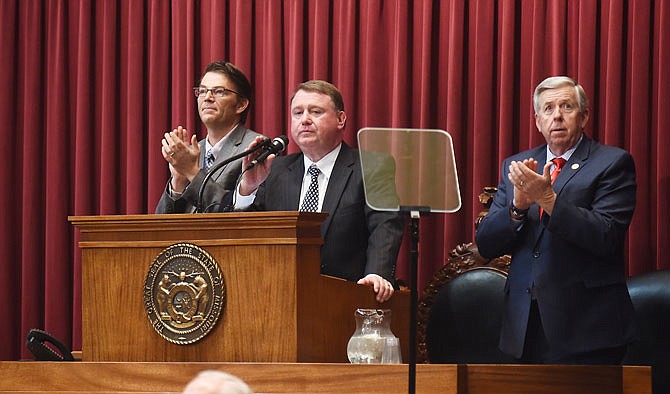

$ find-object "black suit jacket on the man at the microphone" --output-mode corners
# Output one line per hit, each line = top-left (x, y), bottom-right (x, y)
(238, 143), (403, 283)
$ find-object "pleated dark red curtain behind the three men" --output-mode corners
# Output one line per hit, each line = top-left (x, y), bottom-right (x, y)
(0, 0), (670, 360)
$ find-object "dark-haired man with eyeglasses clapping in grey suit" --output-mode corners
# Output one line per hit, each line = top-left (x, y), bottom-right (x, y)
(156, 62), (260, 213)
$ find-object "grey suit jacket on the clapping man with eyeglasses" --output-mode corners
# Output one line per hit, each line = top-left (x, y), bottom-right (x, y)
(156, 124), (260, 213)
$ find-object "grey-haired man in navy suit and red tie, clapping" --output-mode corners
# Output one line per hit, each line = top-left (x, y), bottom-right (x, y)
(476, 76), (637, 364)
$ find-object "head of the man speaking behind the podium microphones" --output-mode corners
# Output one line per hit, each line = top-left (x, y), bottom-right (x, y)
(290, 80), (347, 162)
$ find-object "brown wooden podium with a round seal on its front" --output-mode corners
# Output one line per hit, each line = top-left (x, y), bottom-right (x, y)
(68, 212), (409, 363)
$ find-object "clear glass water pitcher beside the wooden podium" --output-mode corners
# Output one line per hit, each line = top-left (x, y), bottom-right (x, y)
(347, 309), (400, 364)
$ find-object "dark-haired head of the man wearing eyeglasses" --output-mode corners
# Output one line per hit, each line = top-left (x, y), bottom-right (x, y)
(198, 62), (251, 124)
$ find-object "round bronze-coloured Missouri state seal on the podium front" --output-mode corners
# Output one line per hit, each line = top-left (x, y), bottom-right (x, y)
(144, 243), (226, 345)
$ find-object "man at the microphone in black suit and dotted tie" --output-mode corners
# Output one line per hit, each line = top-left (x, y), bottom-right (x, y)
(230, 80), (403, 302)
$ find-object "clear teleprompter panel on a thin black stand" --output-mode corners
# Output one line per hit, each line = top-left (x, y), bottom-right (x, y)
(358, 127), (461, 394)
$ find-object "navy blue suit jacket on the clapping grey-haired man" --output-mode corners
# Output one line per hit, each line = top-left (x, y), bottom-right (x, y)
(476, 136), (636, 357)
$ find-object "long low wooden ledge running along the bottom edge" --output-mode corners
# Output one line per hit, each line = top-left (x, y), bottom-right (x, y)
(0, 362), (651, 394)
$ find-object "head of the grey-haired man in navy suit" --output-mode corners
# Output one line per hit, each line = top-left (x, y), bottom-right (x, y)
(533, 76), (589, 155)
